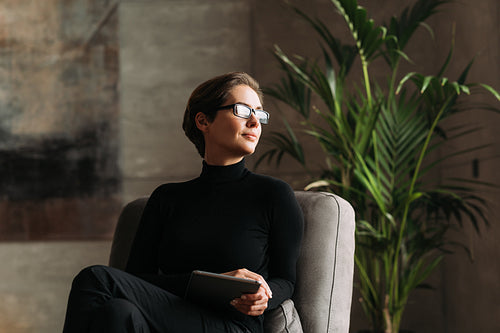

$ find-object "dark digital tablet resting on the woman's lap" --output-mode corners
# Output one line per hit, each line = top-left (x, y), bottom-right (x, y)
(186, 271), (260, 305)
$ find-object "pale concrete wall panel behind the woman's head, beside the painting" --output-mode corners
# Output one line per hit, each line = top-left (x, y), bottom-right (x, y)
(120, 1), (252, 200)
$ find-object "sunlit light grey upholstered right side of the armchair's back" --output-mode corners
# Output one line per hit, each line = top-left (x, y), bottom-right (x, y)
(293, 192), (355, 333)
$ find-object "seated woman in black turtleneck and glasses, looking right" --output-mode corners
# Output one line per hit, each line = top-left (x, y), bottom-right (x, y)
(64, 72), (303, 333)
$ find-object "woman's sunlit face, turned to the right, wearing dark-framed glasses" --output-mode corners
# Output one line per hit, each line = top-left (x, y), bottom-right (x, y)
(200, 85), (262, 165)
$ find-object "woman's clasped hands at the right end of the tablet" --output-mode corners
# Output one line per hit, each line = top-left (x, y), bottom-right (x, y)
(223, 268), (272, 316)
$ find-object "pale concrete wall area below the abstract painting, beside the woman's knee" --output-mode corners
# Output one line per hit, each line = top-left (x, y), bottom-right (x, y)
(0, 241), (110, 333)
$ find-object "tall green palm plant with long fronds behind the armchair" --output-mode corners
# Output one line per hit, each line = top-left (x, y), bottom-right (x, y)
(257, 0), (500, 333)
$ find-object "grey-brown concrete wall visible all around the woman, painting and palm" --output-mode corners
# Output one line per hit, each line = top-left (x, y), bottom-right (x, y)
(0, 0), (500, 333)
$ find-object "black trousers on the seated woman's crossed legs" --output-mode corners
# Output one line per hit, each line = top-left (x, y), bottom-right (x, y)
(63, 266), (249, 333)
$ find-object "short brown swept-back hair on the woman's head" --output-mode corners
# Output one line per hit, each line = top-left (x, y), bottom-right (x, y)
(182, 72), (263, 157)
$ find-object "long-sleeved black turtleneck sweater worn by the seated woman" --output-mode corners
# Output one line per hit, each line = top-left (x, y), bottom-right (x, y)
(126, 159), (303, 332)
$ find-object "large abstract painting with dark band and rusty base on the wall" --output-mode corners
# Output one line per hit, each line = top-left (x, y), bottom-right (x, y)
(0, 0), (121, 241)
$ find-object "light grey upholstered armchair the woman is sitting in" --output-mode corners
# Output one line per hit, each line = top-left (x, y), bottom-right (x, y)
(109, 191), (354, 333)
